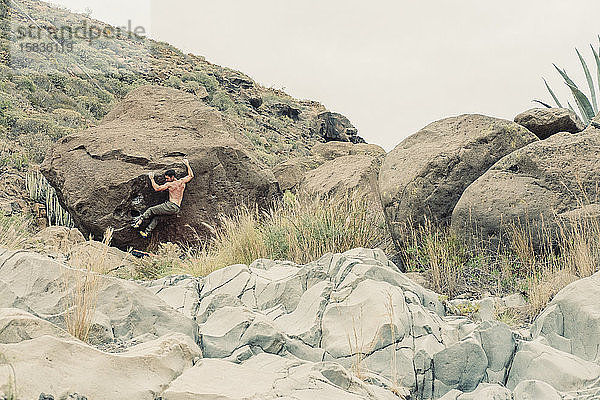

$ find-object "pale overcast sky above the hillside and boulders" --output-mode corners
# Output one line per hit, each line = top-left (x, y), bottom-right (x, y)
(52, 0), (600, 150)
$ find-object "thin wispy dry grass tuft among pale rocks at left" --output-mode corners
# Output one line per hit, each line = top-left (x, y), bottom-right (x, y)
(63, 229), (112, 342)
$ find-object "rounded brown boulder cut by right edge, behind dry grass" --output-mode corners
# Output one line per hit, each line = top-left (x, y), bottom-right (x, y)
(452, 131), (600, 248)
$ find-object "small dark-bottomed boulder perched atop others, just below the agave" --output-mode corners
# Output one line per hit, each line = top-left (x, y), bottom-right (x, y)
(515, 108), (585, 139)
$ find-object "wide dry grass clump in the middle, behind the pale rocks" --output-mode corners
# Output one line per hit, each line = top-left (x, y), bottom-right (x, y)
(142, 193), (391, 276)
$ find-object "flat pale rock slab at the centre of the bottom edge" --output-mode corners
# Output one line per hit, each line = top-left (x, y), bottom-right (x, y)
(162, 354), (398, 400)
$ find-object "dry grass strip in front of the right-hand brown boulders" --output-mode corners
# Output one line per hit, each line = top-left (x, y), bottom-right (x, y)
(401, 203), (600, 320)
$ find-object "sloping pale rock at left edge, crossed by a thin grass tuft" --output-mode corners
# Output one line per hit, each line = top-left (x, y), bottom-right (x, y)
(0, 250), (198, 343)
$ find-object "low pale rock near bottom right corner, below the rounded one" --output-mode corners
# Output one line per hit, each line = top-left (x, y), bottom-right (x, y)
(506, 339), (600, 392)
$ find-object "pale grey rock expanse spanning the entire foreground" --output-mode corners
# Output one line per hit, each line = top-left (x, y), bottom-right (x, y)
(0, 245), (600, 400)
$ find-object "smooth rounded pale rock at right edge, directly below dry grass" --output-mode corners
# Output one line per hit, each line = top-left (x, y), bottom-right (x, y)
(532, 273), (600, 364)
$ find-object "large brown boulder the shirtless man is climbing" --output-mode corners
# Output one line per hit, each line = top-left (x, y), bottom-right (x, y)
(42, 86), (279, 246)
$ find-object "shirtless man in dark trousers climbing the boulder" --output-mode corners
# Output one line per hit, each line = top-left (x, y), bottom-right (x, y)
(133, 158), (194, 238)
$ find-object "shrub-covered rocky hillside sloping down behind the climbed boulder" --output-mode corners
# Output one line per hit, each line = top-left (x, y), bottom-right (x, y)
(0, 0), (362, 168)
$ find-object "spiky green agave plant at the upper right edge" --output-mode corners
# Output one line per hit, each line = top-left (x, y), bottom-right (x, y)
(534, 35), (600, 125)
